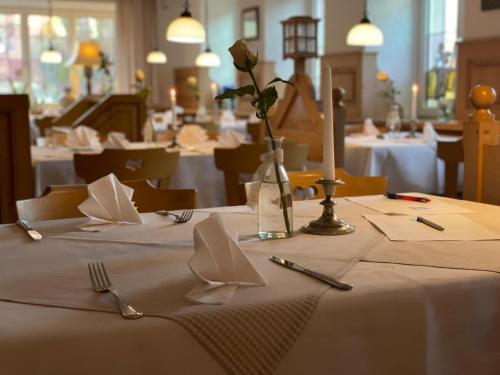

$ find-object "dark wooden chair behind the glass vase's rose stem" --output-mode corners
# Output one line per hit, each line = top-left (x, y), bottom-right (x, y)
(214, 142), (308, 206)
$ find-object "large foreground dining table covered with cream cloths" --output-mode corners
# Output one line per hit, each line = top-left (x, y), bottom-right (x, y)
(0, 196), (500, 375)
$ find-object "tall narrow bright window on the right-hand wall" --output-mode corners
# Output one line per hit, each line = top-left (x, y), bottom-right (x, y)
(424, 0), (459, 112)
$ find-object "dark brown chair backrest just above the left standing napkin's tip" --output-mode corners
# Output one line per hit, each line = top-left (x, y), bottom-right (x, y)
(74, 148), (179, 187)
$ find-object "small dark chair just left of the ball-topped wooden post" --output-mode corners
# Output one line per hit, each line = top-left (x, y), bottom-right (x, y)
(437, 139), (464, 198)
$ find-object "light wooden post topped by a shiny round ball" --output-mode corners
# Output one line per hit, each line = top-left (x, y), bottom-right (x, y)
(463, 85), (500, 205)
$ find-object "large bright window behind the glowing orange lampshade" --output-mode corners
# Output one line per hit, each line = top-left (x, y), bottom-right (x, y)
(0, 3), (116, 104)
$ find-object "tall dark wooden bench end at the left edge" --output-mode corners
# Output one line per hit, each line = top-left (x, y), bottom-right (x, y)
(0, 95), (33, 223)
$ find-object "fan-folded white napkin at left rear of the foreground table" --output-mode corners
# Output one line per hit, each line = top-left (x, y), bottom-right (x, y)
(78, 173), (142, 230)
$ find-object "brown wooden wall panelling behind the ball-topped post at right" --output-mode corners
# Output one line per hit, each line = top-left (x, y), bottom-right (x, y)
(455, 38), (500, 120)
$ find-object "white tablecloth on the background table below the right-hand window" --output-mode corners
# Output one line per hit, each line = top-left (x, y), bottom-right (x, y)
(344, 136), (463, 194)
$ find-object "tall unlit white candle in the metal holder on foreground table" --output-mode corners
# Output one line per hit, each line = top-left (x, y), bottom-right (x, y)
(323, 66), (335, 180)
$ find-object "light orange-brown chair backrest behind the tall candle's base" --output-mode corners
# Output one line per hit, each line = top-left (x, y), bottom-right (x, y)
(288, 168), (387, 200)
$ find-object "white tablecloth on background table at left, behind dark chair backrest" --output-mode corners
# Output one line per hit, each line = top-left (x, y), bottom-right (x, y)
(31, 142), (226, 208)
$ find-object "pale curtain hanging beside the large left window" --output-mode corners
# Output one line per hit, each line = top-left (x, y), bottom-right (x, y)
(116, 0), (158, 103)
